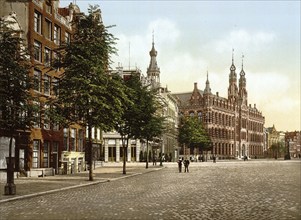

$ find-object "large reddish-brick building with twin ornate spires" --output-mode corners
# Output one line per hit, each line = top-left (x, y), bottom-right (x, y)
(173, 54), (265, 159)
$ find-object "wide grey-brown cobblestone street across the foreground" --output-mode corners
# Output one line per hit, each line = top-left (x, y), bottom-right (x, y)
(0, 160), (301, 220)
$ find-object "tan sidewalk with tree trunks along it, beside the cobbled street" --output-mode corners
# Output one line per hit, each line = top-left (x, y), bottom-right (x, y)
(0, 163), (163, 204)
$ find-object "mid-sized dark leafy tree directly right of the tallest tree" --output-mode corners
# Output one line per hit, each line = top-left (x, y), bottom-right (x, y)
(116, 75), (163, 174)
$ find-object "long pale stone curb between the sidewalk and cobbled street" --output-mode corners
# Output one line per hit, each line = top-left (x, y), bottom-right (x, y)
(0, 167), (164, 204)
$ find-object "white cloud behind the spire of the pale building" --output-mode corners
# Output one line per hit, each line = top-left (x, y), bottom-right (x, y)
(112, 19), (180, 73)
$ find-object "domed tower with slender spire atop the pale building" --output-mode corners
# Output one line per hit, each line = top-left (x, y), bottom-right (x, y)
(147, 34), (160, 88)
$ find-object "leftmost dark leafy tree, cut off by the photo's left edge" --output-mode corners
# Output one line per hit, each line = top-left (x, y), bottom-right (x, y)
(0, 15), (34, 194)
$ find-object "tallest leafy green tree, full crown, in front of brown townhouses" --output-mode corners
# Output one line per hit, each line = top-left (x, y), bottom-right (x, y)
(48, 6), (128, 181)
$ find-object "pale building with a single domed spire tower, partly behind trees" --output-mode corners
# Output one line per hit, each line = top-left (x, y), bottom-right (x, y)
(100, 37), (178, 162)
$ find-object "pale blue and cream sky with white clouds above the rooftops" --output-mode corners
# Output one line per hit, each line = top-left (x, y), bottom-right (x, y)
(60, 0), (301, 131)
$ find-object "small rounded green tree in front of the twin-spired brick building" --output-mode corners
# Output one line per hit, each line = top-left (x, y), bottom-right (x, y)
(178, 116), (211, 158)
